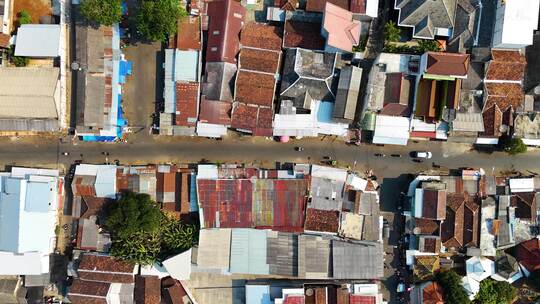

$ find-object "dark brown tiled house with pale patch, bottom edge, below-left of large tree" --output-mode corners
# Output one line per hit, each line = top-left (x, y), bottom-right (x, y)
(67, 252), (137, 304)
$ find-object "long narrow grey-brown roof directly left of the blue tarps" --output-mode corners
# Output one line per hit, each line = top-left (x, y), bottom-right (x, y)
(75, 25), (108, 127)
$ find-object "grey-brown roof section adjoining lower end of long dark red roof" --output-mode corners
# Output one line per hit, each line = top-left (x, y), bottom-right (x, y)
(202, 62), (237, 101)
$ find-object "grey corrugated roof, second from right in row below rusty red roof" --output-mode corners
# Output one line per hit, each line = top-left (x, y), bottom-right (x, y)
(298, 234), (331, 279)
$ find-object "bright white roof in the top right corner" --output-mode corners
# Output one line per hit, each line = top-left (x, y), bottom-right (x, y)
(492, 0), (540, 49)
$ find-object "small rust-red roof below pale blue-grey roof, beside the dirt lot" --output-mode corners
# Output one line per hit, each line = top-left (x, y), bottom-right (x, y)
(176, 82), (199, 127)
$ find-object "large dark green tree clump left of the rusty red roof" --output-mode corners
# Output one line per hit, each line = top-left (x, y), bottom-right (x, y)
(105, 192), (198, 265)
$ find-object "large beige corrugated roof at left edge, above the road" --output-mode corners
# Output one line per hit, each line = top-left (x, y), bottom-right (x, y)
(0, 67), (60, 119)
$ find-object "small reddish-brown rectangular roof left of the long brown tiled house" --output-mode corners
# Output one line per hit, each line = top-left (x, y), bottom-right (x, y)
(426, 52), (469, 76)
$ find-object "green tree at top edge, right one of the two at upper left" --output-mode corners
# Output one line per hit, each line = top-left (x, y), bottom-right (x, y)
(136, 0), (187, 41)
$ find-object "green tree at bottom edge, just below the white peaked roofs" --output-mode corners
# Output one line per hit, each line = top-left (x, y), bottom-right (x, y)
(474, 279), (517, 304)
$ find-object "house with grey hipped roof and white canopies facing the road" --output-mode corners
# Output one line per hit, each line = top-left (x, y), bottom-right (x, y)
(274, 48), (348, 136)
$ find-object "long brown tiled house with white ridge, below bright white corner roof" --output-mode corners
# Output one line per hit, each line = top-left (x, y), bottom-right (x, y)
(479, 50), (526, 144)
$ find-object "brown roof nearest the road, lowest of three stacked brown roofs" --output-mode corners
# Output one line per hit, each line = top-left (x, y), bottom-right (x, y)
(231, 103), (273, 136)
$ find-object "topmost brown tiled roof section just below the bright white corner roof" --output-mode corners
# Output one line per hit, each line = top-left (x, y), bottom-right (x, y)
(486, 50), (527, 81)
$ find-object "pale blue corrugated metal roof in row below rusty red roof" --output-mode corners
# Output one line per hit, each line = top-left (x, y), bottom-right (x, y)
(230, 229), (270, 274)
